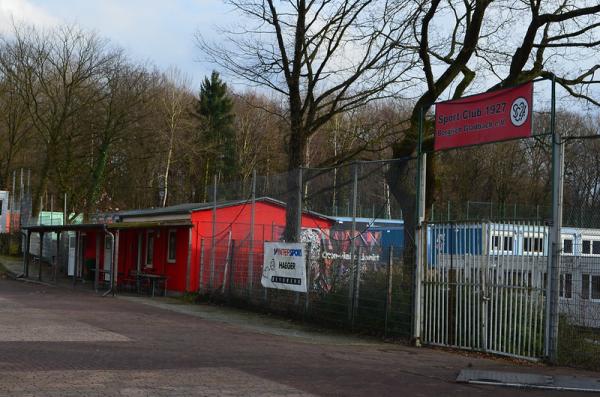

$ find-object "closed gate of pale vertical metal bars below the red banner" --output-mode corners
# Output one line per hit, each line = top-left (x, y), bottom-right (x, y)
(421, 222), (548, 359)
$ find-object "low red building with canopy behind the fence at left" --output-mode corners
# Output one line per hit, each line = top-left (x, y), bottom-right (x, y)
(56, 198), (334, 293)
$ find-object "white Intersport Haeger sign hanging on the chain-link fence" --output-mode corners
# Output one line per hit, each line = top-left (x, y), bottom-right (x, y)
(260, 243), (306, 292)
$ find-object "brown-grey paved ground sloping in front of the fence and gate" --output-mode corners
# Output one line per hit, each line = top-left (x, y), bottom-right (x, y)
(0, 278), (594, 397)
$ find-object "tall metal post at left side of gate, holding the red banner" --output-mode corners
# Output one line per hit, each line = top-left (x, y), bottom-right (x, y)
(413, 108), (427, 346)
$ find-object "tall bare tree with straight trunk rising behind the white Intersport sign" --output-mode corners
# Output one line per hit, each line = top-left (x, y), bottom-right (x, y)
(198, 0), (413, 241)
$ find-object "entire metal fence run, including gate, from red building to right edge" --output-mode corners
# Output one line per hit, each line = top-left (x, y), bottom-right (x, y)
(17, 142), (600, 369)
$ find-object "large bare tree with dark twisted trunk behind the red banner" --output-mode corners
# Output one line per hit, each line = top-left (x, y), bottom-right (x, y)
(389, 0), (600, 237)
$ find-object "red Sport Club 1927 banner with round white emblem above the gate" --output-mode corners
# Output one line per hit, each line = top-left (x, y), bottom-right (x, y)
(434, 82), (533, 150)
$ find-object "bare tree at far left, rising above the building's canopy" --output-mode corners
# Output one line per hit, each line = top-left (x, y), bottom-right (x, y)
(0, 26), (115, 216)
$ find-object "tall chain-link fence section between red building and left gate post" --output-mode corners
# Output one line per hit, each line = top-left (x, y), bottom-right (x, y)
(190, 159), (415, 338)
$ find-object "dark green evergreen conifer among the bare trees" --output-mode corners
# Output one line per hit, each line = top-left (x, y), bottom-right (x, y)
(196, 71), (237, 185)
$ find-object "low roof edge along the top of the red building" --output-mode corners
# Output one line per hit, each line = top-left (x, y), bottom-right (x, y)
(115, 197), (333, 221)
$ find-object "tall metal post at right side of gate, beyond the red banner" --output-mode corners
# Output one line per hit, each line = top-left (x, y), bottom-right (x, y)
(544, 76), (565, 363)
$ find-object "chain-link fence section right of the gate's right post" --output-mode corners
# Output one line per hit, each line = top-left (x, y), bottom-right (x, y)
(558, 132), (600, 370)
